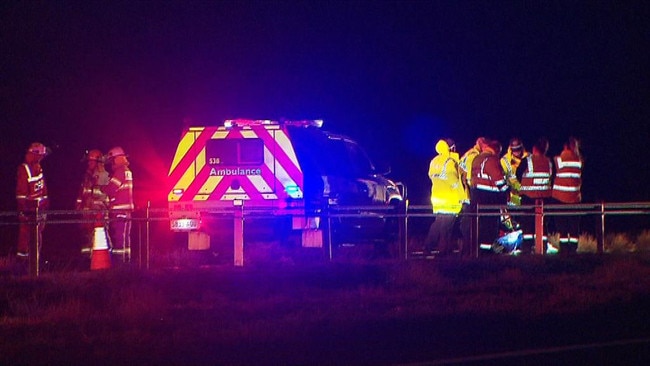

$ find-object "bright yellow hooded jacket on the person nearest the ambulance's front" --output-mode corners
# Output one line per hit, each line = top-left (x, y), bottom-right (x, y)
(429, 140), (467, 214)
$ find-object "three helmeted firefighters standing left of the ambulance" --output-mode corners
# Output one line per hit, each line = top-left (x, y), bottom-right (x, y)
(16, 142), (134, 262)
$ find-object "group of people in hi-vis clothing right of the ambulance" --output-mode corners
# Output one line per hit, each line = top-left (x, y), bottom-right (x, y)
(424, 137), (583, 257)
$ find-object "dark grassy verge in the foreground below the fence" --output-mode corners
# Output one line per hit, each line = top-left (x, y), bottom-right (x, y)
(0, 252), (650, 365)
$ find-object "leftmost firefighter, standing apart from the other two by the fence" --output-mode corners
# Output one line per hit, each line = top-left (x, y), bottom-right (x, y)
(16, 142), (50, 259)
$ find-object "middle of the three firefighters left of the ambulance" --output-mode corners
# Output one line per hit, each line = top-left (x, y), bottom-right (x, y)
(75, 150), (109, 254)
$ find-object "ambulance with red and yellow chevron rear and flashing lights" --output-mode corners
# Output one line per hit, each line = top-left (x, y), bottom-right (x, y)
(168, 119), (405, 250)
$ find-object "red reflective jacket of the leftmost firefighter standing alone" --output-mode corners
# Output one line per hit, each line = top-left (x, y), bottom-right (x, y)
(16, 163), (48, 211)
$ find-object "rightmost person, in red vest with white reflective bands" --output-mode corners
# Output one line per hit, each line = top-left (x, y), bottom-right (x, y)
(551, 137), (584, 254)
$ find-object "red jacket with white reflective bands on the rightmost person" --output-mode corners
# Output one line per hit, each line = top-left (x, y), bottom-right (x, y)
(552, 149), (582, 203)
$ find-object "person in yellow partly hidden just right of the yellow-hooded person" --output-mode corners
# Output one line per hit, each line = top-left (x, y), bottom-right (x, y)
(458, 137), (486, 257)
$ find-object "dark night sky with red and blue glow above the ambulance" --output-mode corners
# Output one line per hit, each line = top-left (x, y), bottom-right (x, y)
(0, 0), (650, 210)
